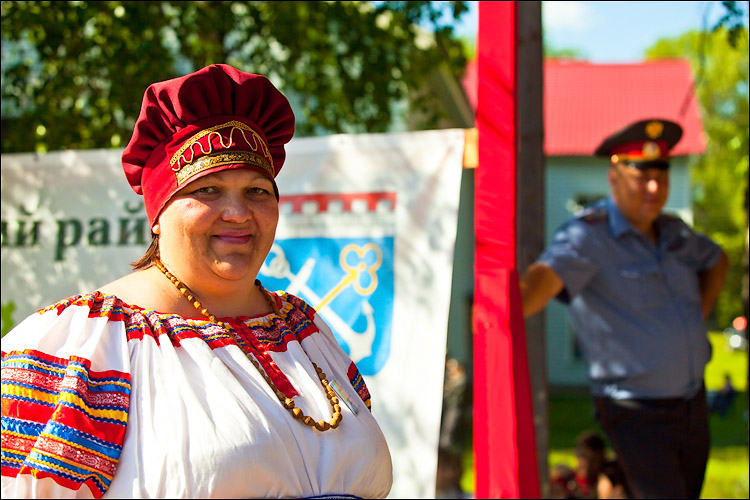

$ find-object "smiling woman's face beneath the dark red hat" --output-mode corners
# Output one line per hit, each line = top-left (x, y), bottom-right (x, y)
(153, 169), (279, 280)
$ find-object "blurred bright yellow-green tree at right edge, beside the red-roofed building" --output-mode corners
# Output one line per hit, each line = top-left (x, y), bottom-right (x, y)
(646, 26), (748, 326)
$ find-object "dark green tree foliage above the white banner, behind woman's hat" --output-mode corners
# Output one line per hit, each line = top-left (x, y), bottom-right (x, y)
(1, 1), (467, 152)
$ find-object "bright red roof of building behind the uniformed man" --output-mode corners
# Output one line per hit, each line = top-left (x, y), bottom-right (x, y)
(462, 59), (706, 156)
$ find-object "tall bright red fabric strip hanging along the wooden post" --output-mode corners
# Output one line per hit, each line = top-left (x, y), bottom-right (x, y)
(473, 1), (541, 498)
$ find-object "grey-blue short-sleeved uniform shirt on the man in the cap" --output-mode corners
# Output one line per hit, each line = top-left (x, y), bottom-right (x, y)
(539, 197), (721, 399)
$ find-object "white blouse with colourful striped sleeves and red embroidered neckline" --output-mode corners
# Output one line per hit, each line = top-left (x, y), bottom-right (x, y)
(2, 292), (393, 498)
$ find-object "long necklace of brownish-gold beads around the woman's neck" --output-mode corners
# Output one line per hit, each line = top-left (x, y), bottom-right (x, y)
(154, 259), (343, 431)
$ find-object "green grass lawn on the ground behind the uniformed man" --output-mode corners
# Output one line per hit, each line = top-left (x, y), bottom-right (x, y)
(461, 333), (750, 498)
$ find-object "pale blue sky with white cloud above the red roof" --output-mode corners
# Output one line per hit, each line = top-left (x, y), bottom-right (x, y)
(456, 1), (748, 63)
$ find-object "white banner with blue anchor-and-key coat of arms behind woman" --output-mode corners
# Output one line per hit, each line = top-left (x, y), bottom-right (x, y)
(1, 129), (464, 498)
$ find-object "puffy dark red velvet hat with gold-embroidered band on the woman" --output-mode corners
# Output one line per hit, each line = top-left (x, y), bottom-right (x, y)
(122, 64), (294, 226)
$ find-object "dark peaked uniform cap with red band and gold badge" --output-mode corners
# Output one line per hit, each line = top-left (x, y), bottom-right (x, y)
(594, 118), (682, 169)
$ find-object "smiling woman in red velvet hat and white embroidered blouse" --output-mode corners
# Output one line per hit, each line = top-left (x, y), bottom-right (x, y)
(2, 64), (392, 498)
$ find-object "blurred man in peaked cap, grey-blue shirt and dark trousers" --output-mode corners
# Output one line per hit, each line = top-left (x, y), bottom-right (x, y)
(520, 119), (728, 498)
